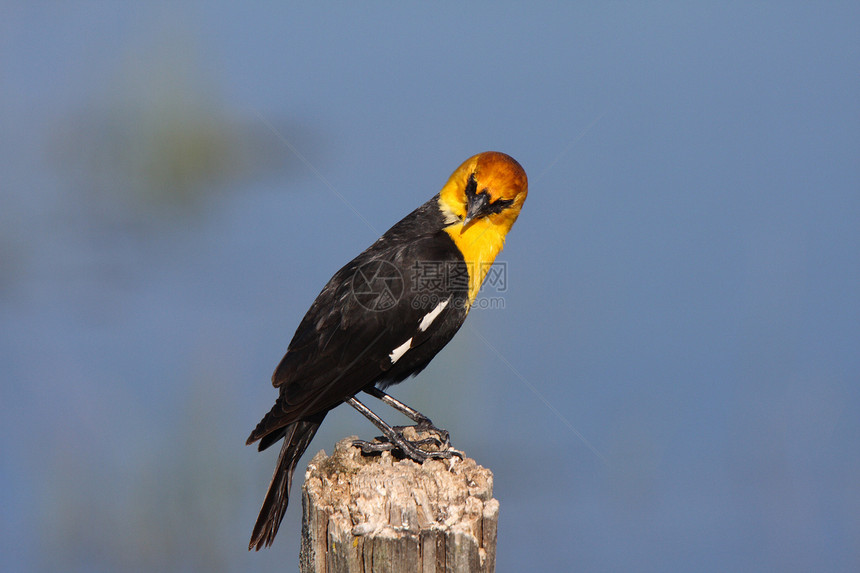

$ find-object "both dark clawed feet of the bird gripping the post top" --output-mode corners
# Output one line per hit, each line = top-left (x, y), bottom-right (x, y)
(352, 419), (463, 464)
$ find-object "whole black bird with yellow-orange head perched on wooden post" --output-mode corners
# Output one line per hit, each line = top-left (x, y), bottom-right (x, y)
(246, 151), (528, 550)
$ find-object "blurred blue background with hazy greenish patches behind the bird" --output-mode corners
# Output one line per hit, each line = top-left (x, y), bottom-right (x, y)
(0, 2), (860, 572)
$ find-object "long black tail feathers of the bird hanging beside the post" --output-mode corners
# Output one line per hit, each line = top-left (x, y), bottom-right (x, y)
(248, 412), (325, 551)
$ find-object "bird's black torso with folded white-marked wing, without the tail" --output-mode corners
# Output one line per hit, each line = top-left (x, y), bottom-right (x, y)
(252, 206), (468, 445)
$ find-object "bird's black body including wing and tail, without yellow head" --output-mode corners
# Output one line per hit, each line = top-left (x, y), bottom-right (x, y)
(242, 195), (468, 549)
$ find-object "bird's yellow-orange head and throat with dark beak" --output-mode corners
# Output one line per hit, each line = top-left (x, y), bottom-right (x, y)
(439, 151), (528, 304)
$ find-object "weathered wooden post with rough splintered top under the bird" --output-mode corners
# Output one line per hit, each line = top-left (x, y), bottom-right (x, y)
(300, 437), (499, 573)
